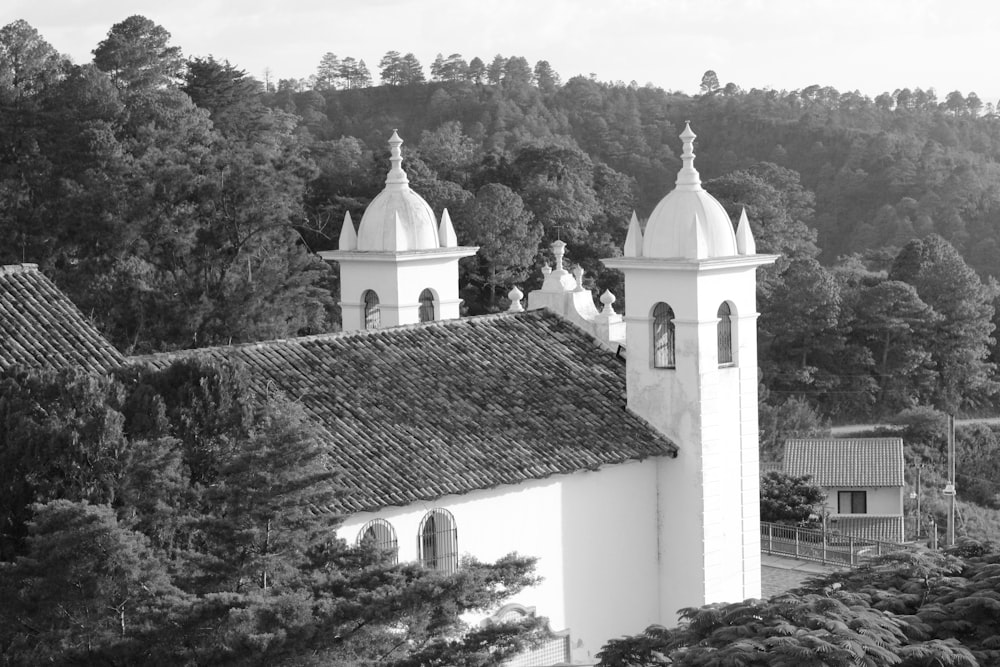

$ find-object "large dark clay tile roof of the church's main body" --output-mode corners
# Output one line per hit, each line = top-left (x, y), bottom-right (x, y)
(134, 310), (677, 512)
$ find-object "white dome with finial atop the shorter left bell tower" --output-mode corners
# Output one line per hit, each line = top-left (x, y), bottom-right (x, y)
(357, 130), (440, 251)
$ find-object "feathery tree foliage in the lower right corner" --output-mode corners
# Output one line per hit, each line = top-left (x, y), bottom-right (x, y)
(600, 541), (1000, 667)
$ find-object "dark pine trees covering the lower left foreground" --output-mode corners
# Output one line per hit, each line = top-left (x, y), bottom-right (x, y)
(0, 361), (547, 666)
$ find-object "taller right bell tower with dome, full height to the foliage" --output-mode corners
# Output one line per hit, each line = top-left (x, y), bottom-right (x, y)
(603, 126), (776, 625)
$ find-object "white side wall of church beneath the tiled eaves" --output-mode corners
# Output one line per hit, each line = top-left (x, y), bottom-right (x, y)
(337, 459), (664, 656)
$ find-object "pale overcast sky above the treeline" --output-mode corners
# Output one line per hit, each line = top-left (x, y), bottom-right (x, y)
(7, 0), (1000, 104)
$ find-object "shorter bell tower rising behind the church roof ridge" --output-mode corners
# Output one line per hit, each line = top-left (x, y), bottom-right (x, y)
(319, 130), (479, 331)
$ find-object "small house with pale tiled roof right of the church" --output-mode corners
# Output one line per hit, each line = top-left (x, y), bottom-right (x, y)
(784, 438), (905, 542)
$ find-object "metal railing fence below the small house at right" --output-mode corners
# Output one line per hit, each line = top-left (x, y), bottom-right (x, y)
(760, 521), (911, 567)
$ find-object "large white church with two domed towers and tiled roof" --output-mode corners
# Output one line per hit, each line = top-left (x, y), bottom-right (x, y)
(0, 127), (775, 664)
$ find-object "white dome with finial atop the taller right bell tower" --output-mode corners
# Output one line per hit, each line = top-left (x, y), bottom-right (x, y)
(642, 125), (737, 259)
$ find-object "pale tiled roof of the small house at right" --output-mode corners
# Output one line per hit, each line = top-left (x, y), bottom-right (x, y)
(785, 438), (903, 487)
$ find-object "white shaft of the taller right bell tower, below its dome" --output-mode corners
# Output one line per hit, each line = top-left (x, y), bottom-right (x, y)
(604, 256), (772, 624)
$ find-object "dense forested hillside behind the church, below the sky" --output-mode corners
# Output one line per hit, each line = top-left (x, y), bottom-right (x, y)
(0, 16), (1000, 428)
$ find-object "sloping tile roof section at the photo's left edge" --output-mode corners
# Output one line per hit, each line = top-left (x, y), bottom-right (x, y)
(0, 264), (124, 373)
